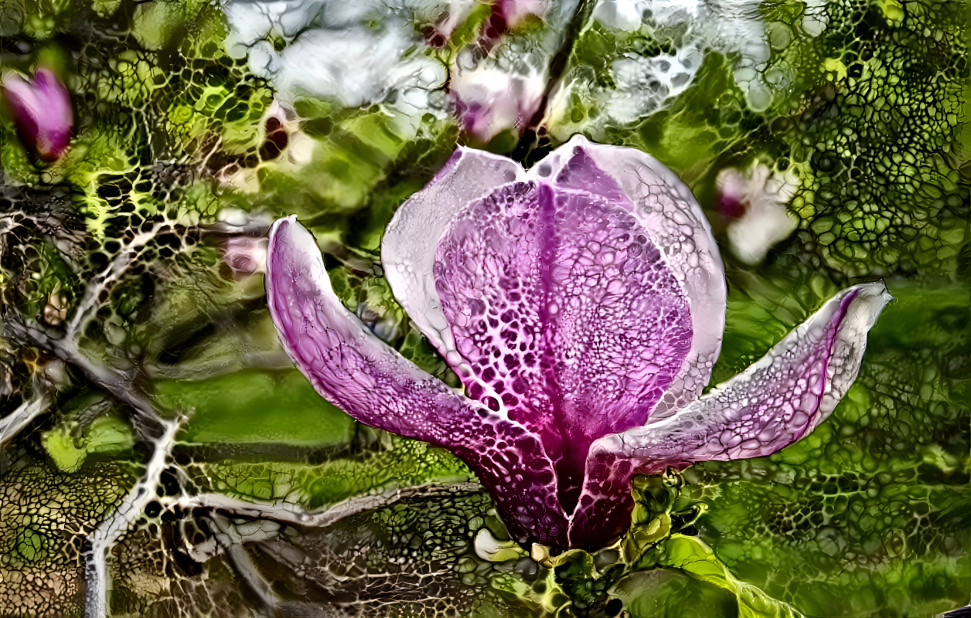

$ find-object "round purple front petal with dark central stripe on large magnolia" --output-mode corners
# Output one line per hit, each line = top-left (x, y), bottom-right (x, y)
(435, 181), (691, 512)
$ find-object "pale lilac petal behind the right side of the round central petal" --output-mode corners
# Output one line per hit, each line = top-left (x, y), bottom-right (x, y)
(529, 135), (725, 417)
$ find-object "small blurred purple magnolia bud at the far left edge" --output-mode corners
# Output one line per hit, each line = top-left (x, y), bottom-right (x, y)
(3, 68), (74, 163)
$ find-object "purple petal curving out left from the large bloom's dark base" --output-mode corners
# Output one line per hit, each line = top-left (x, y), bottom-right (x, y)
(266, 217), (566, 547)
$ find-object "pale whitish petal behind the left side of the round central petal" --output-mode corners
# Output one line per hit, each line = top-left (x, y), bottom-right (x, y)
(381, 148), (524, 378)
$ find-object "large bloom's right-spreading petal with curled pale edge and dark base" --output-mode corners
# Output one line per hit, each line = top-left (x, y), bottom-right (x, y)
(570, 282), (890, 546)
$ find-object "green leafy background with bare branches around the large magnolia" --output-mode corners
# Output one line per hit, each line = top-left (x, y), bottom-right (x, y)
(0, 0), (971, 616)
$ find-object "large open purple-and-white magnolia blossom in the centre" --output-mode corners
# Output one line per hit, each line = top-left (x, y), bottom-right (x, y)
(266, 137), (890, 551)
